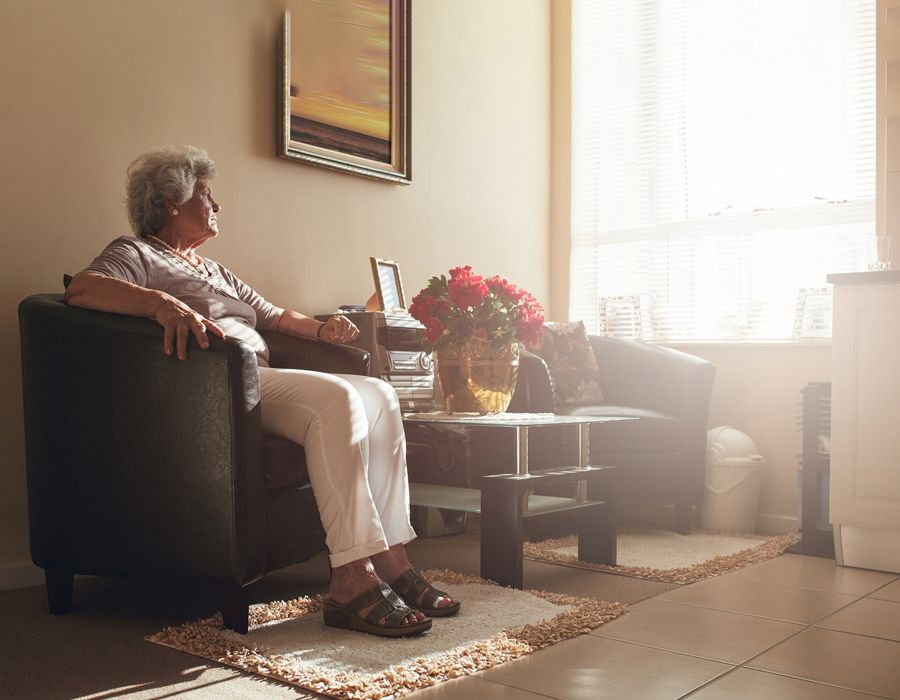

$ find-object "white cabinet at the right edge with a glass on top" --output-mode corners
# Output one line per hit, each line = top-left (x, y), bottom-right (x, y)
(828, 271), (900, 572)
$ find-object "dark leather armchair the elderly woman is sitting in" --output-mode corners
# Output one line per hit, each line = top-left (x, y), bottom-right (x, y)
(19, 294), (369, 632)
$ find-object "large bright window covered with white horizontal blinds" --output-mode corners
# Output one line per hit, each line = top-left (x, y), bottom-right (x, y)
(570, 0), (875, 342)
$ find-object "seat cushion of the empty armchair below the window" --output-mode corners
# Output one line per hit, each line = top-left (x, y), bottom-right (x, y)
(559, 405), (685, 454)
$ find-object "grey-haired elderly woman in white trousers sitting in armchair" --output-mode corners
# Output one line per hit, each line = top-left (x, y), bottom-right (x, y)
(66, 146), (459, 637)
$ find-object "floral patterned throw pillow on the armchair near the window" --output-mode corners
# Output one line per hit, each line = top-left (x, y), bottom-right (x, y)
(535, 321), (603, 409)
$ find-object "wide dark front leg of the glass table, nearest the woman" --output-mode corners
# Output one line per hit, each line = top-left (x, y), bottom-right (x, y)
(481, 476), (523, 588)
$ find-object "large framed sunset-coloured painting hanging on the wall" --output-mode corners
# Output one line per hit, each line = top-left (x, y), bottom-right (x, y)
(278, 0), (412, 184)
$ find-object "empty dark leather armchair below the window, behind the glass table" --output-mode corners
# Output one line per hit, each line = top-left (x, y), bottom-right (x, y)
(472, 336), (715, 534)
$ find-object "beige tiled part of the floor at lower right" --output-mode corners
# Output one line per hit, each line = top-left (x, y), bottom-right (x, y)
(414, 554), (900, 700)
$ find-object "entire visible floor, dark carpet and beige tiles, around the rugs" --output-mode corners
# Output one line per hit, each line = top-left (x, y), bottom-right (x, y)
(0, 535), (900, 700)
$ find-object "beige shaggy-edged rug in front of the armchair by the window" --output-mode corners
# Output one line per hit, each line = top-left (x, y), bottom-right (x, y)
(525, 528), (800, 584)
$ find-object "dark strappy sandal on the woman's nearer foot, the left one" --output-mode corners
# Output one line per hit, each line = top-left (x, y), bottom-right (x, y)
(322, 581), (431, 637)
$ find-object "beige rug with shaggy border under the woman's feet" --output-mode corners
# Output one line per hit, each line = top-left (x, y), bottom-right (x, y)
(147, 571), (625, 700)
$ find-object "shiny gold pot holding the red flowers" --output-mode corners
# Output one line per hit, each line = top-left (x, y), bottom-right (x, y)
(435, 343), (519, 414)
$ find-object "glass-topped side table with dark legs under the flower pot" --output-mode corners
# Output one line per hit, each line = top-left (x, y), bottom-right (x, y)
(403, 413), (632, 588)
